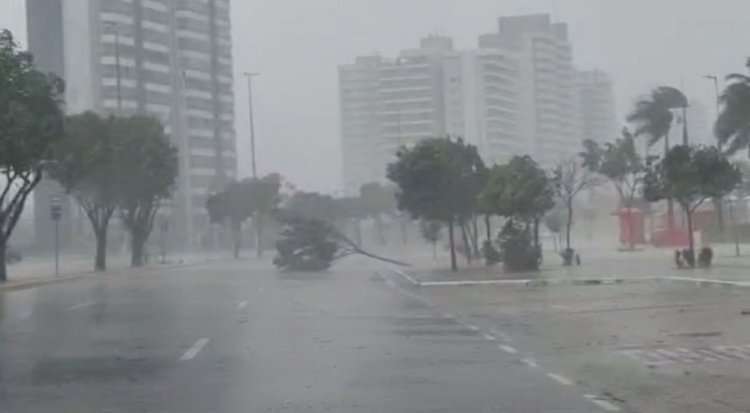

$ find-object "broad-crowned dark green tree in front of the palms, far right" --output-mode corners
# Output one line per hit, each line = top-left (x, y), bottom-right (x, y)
(644, 145), (742, 257)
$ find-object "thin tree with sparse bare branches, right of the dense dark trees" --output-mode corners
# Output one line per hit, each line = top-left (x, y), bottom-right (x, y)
(553, 157), (601, 265)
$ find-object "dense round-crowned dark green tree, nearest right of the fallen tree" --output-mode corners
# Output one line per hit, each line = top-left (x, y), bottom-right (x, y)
(388, 138), (484, 271)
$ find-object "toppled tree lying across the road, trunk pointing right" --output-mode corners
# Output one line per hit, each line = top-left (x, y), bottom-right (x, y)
(273, 211), (408, 272)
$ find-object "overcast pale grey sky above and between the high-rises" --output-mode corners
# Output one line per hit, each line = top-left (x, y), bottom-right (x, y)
(0, 0), (750, 191)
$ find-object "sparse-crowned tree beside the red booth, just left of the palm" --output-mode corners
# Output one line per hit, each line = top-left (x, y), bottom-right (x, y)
(581, 129), (646, 250)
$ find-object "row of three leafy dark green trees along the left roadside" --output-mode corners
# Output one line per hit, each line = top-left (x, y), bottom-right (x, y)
(0, 31), (178, 282)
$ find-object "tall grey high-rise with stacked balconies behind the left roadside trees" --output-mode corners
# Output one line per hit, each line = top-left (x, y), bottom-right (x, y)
(27, 0), (237, 247)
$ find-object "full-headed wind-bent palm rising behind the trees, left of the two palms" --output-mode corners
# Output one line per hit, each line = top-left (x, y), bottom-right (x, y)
(627, 86), (688, 231)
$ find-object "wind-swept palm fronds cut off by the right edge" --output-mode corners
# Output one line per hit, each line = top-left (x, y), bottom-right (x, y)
(714, 58), (750, 155)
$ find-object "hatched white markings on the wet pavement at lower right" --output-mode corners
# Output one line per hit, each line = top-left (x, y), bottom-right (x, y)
(619, 344), (750, 366)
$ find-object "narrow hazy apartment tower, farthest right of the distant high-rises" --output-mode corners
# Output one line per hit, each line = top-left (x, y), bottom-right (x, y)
(576, 70), (619, 142)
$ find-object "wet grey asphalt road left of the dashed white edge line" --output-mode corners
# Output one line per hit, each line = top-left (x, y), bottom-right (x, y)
(0, 262), (608, 413)
